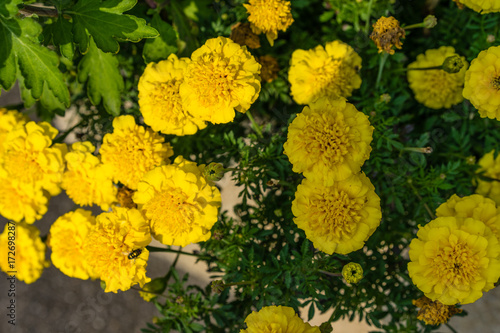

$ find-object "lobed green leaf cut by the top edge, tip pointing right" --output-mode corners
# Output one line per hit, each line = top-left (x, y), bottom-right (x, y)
(65, 0), (158, 54)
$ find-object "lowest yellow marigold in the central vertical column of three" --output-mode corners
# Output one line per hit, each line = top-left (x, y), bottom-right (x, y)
(292, 173), (382, 254)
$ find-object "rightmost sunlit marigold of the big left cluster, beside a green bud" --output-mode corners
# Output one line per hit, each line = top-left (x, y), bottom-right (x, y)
(133, 156), (221, 246)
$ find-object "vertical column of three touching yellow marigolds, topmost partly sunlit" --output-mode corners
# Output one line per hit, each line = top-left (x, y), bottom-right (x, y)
(283, 41), (382, 254)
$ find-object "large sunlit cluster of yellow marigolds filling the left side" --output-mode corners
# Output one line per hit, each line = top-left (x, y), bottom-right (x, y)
(0, 109), (221, 292)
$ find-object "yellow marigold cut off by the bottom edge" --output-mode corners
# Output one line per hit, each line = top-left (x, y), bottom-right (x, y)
(240, 305), (320, 333)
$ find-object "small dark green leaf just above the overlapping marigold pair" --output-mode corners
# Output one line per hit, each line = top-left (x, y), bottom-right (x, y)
(142, 14), (177, 63)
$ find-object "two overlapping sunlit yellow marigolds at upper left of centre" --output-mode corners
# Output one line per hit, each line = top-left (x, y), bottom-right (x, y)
(139, 37), (261, 131)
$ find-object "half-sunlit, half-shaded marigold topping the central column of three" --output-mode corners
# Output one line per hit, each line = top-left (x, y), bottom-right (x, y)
(288, 40), (361, 104)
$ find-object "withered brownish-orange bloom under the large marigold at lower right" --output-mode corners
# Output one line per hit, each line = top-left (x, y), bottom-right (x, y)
(412, 296), (462, 325)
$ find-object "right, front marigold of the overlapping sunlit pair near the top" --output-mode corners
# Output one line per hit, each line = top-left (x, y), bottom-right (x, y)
(180, 37), (261, 124)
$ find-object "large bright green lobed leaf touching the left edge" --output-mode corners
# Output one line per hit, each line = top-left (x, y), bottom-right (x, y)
(0, 17), (69, 106)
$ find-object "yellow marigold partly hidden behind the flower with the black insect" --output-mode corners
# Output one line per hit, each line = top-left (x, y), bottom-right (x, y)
(49, 209), (96, 280)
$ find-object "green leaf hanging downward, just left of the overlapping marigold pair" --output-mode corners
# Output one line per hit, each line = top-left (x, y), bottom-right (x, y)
(78, 39), (124, 117)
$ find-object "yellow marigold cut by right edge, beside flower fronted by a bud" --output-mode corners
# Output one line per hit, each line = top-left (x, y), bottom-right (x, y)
(463, 46), (500, 120)
